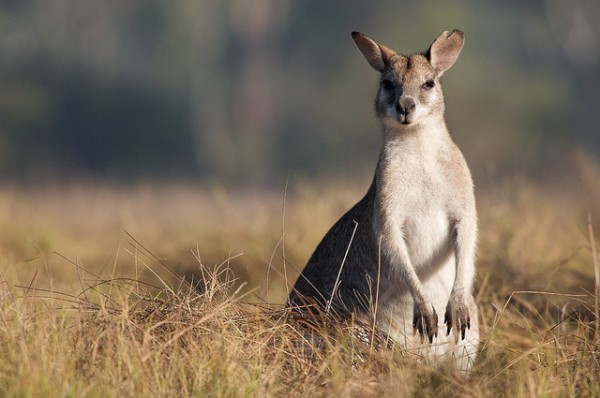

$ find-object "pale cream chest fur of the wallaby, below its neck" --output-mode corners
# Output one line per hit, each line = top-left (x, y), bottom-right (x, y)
(376, 126), (453, 273)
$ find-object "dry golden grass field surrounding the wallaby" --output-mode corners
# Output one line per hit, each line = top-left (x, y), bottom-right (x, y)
(0, 159), (600, 397)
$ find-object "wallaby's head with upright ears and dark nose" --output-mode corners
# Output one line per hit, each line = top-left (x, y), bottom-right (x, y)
(352, 29), (464, 128)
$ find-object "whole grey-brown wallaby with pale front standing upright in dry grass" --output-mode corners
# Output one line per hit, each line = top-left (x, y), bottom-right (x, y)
(289, 29), (479, 371)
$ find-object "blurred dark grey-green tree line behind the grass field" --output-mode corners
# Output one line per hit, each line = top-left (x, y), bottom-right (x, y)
(0, 0), (600, 183)
